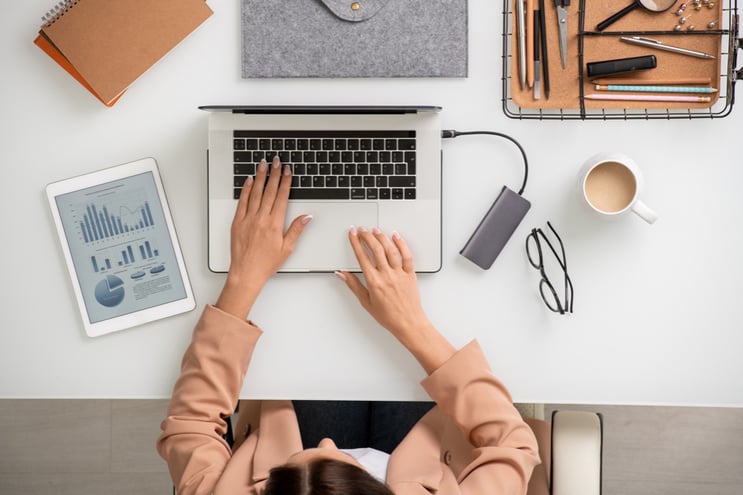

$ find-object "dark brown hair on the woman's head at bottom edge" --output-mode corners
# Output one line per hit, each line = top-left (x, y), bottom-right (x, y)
(265, 459), (393, 495)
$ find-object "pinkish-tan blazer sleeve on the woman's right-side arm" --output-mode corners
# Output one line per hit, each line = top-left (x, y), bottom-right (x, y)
(422, 341), (540, 494)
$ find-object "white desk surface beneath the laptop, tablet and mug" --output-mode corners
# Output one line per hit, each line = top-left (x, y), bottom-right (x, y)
(0, 0), (743, 406)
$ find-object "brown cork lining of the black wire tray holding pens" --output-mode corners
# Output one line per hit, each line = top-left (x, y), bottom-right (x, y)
(510, 0), (722, 110)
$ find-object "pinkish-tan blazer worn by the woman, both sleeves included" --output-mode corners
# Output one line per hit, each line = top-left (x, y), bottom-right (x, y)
(157, 306), (540, 495)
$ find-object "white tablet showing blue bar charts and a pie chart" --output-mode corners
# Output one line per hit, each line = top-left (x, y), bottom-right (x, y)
(46, 158), (196, 337)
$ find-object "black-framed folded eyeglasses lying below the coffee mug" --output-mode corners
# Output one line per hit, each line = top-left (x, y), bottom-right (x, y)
(526, 222), (573, 315)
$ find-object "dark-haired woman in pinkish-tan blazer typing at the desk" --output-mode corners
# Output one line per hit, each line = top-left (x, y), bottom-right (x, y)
(157, 158), (539, 495)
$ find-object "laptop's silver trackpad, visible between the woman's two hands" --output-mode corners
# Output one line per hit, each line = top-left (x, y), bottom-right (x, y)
(282, 202), (379, 271)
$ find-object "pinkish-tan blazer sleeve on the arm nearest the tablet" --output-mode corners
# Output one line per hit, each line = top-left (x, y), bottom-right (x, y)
(157, 306), (262, 495)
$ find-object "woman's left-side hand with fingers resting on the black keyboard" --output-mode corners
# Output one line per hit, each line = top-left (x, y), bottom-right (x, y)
(216, 157), (312, 318)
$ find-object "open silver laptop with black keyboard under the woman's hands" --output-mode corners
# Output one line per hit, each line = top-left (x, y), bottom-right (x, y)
(199, 106), (441, 272)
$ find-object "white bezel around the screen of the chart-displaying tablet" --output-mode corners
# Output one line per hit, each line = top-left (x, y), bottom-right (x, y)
(46, 158), (196, 337)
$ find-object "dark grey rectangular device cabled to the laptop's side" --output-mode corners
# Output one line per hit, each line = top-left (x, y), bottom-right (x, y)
(459, 186), (531, 270)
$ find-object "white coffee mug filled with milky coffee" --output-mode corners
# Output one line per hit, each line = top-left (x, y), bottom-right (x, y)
(579, 152), (658, 223)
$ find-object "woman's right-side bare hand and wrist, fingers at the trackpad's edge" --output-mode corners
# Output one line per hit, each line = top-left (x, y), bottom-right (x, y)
(337, 228), (454, 373)
